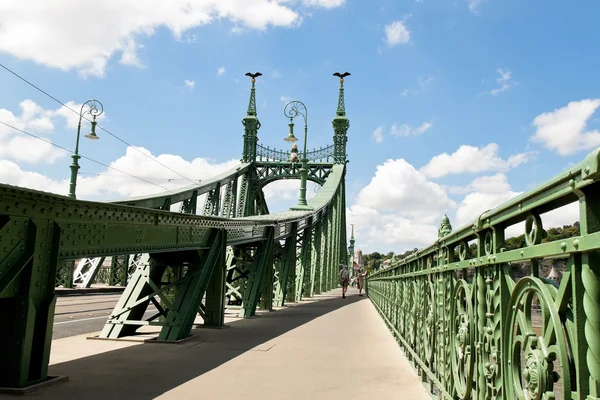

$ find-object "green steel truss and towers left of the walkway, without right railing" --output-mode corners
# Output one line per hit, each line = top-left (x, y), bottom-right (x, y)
(0, 73), (346, 387)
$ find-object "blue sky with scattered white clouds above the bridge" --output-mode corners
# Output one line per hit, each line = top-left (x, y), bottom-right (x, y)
(0, 0), (600, 252)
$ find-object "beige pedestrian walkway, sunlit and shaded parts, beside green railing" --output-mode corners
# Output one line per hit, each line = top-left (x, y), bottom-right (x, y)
(8, 289), (430, 400)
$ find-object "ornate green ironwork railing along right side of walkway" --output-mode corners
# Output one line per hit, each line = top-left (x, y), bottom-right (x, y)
(367, 149), (600, 400)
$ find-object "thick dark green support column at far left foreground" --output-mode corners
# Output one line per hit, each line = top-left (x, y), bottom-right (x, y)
(0, 218), (60, 388)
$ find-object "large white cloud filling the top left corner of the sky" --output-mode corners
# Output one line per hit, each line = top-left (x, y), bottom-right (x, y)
(0, 0), (343, 76)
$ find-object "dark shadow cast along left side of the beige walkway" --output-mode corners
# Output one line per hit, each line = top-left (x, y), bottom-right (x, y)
(19, 291), (366, 400)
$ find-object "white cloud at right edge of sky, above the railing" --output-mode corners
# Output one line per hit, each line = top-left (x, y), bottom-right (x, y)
(531, 99), (600, 156)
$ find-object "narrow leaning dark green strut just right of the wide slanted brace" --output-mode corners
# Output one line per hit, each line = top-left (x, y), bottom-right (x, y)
(240, 226), (275, 318)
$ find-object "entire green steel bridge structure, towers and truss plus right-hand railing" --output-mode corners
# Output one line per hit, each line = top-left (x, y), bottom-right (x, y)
(0, 72), (600, 400)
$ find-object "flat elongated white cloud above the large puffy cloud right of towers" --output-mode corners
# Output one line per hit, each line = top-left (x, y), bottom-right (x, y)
(420, 143), (535, 178)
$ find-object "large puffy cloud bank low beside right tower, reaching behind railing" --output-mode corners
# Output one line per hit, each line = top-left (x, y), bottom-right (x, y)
(346, 150), (579, 253)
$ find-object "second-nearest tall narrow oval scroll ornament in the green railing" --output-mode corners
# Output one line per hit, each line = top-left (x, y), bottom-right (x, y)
(451, 279), (475, 399)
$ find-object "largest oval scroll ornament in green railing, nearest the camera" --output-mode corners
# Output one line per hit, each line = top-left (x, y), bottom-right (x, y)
(502, 277), (571, 400)
